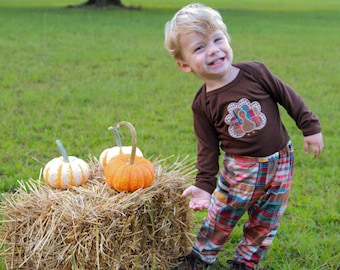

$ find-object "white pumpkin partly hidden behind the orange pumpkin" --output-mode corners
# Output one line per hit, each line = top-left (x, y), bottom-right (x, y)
(99, 127), (143, 168)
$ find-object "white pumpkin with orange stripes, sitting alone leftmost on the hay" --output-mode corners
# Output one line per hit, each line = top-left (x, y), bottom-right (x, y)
(43, 140), (91, 189)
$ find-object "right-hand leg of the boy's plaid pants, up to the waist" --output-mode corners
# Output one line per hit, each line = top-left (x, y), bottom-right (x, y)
(235, 143), (294, 267)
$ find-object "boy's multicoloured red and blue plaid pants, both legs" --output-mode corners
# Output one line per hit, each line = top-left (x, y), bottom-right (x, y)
(193, 142), (294, 267)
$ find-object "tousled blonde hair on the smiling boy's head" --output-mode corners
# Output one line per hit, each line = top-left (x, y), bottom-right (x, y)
(164, 3), (230, 60)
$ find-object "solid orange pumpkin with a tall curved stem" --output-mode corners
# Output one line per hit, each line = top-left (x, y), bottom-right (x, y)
(104, 121), (155, 192)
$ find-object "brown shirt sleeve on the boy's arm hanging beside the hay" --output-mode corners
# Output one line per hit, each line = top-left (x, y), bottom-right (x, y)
(192, 101), (220, 194)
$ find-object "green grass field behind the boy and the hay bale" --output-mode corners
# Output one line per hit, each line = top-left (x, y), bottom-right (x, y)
(0, 0), (340, 270)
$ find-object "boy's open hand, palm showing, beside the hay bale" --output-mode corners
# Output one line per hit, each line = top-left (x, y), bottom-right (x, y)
(182, 186), (211, 211)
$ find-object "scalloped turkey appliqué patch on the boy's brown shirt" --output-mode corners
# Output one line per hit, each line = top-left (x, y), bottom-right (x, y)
(224, 98), (267, 138)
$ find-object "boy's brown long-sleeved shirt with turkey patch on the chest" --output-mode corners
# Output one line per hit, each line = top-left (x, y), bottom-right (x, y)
(192, 62), (321, 193)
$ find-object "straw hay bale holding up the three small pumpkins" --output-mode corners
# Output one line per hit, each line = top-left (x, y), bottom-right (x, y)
(0, 155), (194, 270)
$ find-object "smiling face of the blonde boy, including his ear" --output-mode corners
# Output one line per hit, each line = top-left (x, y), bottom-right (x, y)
(177, 30), (233, 82)
